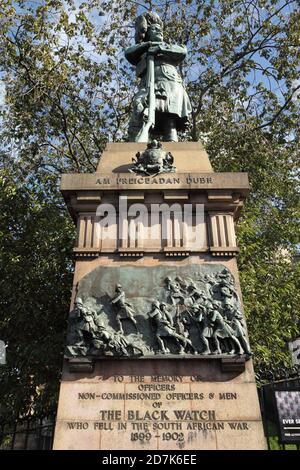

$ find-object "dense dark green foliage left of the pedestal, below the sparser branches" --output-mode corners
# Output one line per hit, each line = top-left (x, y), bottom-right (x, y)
(0, 169), (74, 419)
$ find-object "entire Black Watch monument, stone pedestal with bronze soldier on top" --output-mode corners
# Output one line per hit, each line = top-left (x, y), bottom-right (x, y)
(54, 13), (265, 450)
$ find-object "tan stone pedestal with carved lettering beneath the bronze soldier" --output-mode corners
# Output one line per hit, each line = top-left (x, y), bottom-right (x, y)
(54, 142), (265, 450)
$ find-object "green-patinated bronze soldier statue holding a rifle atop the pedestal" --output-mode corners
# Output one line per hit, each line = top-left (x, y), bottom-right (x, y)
(125, 12), (192, 142)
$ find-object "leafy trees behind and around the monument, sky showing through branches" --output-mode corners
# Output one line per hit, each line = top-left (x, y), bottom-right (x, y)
(0, 0), (300, 415)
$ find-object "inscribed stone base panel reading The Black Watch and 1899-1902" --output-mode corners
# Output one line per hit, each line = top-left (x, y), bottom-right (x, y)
(54, 375), (264, 450)
